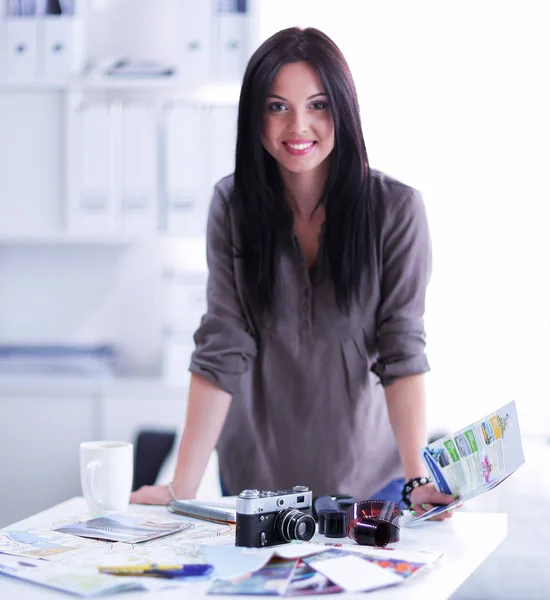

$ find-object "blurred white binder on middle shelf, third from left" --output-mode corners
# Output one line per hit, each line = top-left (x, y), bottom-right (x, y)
(163, 104), (207, 236)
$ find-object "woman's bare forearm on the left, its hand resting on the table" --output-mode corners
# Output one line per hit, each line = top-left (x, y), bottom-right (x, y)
(172, 373), (231, 498)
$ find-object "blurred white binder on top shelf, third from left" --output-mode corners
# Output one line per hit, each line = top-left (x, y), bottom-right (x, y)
(177, 0), (212, 86)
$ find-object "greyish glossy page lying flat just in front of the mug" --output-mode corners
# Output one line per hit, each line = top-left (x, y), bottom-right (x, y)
(54, 515), (193, 544)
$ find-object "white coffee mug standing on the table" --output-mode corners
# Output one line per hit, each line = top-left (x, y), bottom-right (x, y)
(80, 442), (134, 513)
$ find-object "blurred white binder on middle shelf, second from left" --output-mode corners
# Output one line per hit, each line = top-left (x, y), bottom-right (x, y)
(121, 105), (158, 235)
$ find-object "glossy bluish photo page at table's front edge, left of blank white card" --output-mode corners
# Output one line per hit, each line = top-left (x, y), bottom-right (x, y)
(208, 557), (297, 596)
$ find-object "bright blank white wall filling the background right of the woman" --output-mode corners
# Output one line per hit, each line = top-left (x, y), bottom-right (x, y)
(254, 0), (550, 434)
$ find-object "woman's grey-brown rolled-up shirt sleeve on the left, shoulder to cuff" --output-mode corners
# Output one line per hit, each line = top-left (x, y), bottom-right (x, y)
(189, 180), (257, 395)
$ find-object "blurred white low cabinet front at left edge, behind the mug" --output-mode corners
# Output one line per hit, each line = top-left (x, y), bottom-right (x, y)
(0, 391), (98, 527)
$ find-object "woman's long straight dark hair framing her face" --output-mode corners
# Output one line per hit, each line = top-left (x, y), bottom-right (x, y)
(231, 27), (375, 314)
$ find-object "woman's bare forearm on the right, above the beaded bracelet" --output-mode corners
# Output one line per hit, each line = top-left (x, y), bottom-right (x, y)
(386, 375), (427, 480)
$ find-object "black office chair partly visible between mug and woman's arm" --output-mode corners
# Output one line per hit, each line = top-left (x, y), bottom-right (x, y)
(133, 429), (176, 490)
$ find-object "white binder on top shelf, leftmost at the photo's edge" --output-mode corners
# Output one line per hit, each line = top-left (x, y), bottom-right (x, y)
(4, 17), (38, 81)
